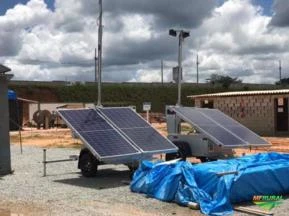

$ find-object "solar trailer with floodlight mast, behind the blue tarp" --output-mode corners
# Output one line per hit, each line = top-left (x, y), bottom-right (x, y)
(166, 106), (271, 161)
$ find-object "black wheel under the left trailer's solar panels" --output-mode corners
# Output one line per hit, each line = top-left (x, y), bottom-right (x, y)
(79, 151), (98, 177)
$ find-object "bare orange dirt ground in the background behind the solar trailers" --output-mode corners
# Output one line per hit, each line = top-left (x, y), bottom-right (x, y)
(10, 123), (289, 155)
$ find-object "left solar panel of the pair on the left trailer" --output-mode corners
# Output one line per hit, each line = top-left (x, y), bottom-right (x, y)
(58, 109), (140, 159)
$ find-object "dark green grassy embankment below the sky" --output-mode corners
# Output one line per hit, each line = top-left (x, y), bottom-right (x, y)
(9, 81), (284, 112)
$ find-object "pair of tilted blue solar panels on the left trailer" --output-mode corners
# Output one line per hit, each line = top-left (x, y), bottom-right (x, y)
(58, 108), (177, 159)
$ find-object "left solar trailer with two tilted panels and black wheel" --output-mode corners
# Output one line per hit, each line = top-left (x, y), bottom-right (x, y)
(57, 107), (178, 177)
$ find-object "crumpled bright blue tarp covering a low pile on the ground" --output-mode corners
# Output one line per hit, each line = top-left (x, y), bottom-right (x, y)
(130, 153), (289, 215)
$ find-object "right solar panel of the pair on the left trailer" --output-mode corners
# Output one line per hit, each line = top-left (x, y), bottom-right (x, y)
(99, 107), (177, 153)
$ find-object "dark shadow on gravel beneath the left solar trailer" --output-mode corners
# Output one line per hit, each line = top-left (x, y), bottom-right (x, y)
(54, 169), (130, 190)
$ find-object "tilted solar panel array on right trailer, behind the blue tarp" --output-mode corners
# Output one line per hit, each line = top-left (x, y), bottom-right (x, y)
(172, 107), (270, 147)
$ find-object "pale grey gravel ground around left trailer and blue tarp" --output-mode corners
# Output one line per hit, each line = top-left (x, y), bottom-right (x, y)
(0, 145), (289, 216)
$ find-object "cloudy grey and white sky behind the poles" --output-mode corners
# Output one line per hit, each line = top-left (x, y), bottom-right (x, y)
(0, 0), (289, 83)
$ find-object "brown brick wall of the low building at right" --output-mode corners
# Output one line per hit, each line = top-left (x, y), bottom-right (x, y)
(195, 94), (289, 136)
